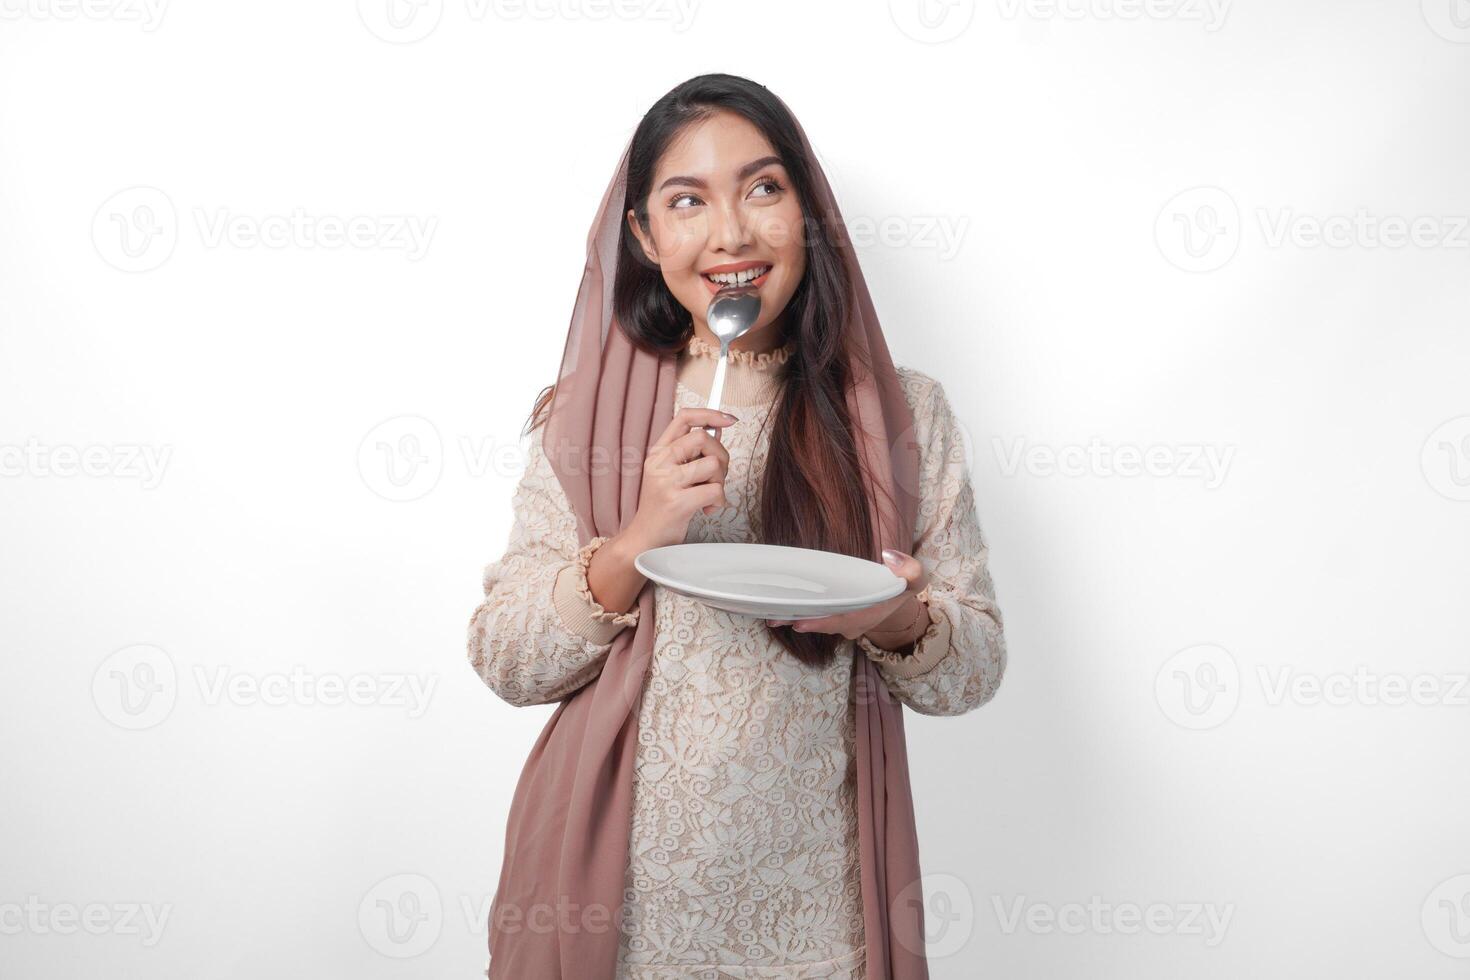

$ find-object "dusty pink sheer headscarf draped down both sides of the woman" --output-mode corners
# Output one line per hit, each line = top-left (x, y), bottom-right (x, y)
(487, 94), (929, 980)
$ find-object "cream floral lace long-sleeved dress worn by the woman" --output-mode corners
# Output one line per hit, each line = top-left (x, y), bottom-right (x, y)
(469, 338), (1005, 980)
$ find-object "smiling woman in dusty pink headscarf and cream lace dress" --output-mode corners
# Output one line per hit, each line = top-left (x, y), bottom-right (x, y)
(469, 75), (1005, 980)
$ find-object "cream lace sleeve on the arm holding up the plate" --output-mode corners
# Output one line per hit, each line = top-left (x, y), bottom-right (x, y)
(857, 369), (1005, 714)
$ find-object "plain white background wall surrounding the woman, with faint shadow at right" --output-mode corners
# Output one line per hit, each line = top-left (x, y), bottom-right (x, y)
(0, 0), (1470, 980)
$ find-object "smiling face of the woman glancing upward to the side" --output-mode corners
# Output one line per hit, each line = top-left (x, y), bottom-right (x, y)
(628, 112), (807, 348)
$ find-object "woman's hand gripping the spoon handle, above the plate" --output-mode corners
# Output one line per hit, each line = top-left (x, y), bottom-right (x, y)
(628, 408), (736, 548)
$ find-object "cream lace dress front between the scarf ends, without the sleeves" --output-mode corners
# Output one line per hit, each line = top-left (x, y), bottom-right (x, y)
(617, 386), (866, 980)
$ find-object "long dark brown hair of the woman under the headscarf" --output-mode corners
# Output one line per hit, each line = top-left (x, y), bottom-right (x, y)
(526, 75), (875, 666)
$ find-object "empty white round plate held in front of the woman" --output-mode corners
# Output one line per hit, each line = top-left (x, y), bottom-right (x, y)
(634, 542), (908, 620)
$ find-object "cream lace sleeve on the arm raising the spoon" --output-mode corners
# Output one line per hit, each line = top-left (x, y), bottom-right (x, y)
(469, 430), (638, 705)
